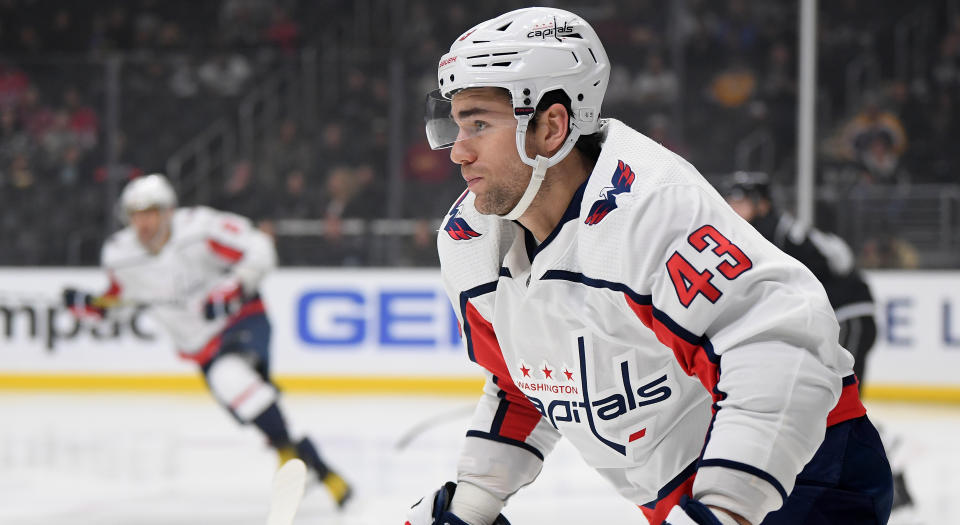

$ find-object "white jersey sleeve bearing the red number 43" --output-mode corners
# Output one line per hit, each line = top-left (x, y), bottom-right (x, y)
(620, 184), (852, 523)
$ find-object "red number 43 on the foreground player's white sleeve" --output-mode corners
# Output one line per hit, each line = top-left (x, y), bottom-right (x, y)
(667, 224), (753, 307)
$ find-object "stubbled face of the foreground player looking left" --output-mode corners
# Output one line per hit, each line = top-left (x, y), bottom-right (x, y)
(450, 88), (532, 215)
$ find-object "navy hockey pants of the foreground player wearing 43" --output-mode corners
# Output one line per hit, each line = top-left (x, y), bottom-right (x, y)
(763, 416), (893, 525)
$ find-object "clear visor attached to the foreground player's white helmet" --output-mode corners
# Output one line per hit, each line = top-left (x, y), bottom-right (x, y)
(424, 89), (517, 149)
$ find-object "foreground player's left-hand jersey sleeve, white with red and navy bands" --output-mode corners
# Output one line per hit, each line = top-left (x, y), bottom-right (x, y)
(445, 264), (560, 500)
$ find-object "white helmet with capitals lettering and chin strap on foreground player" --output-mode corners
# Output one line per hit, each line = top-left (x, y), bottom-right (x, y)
(426, 7), (610, 219)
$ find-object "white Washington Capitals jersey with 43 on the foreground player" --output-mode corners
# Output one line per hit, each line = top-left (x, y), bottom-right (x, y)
(438, 119), (865, 523)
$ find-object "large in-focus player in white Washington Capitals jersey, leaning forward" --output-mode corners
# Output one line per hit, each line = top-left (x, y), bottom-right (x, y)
(407, 8), (891, 525)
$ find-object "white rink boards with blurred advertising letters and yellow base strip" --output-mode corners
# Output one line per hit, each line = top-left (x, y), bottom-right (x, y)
(0, 268), (960, 401)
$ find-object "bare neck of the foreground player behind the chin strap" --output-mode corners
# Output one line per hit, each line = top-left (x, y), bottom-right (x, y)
(518, 151), (592, 242)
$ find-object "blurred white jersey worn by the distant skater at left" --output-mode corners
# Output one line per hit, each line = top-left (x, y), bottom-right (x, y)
(102, 206), (276, 362)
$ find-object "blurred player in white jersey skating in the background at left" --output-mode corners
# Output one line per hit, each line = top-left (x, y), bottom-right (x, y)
(64, 174), (351, 506)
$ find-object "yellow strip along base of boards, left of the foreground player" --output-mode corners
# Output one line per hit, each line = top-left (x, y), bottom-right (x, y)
(0, 374), (483, 395)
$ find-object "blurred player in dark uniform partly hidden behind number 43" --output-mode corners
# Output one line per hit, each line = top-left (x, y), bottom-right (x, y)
(721, 171), (913, 510)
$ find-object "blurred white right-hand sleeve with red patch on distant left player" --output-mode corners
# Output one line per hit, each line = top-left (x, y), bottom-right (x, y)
(205, 210), (277, 293)
